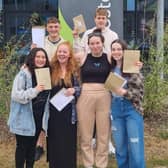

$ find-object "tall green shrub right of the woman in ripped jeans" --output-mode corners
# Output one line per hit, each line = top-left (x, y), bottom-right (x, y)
(143, 26), (168, 116)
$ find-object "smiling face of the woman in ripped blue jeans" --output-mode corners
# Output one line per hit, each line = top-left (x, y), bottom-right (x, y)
(111, 42), (124, 62)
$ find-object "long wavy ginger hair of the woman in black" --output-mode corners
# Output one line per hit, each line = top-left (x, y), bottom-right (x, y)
(51, 41), (79, 87)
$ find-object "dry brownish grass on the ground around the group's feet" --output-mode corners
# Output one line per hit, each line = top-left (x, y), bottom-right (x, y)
(0, 117), (168, 168)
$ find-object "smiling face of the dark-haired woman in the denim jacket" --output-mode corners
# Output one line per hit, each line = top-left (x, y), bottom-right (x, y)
(34, 51), (47, 68)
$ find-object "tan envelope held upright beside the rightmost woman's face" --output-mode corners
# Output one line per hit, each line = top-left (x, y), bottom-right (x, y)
(123, 50), (140, 73)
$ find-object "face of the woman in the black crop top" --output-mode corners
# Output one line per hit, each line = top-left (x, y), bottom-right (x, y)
(88, 36), (103, 56)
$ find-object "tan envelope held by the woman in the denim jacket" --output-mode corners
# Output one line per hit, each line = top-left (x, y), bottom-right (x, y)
(35, 68), (51, 90)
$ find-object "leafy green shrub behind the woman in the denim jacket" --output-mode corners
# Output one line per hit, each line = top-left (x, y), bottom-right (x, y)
(0, 13), (44, 115)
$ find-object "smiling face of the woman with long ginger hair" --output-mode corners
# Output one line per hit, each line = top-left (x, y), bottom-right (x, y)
(56, 44), (70, 64)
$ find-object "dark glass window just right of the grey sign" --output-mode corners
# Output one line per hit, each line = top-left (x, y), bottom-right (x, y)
(124, 0), (157, 47)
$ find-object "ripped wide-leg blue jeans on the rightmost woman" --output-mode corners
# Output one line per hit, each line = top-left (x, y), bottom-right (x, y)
(112, 97), (145, 168)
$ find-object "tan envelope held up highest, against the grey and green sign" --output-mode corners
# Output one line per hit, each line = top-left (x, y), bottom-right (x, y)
(73, 15), (86, 34)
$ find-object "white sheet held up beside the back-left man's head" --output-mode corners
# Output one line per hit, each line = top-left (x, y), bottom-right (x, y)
(32, 26), (45, 48)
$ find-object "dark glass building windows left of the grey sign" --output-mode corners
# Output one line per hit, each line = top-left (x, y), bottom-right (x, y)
(4, 0), (58, 40)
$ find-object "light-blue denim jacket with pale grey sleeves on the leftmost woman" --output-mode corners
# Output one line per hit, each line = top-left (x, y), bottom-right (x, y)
(8, 68), (39, 136)
